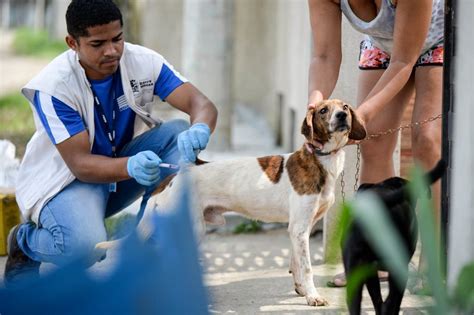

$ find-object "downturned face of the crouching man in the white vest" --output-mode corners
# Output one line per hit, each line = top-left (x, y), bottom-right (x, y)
(66, 20), (124, 80)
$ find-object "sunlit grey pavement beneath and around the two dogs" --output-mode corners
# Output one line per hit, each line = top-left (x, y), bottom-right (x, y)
(0, 228), (431, 314)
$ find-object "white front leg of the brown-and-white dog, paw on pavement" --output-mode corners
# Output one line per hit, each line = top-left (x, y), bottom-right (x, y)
(288, 196), (328, 306)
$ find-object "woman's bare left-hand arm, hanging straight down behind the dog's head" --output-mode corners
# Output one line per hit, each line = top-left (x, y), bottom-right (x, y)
(308, 0), (342, 104)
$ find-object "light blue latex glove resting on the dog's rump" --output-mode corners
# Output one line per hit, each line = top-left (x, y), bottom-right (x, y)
(178, 123), (211, 163)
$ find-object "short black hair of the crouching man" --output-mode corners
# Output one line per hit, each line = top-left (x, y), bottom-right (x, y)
(66, 0), (123, 40)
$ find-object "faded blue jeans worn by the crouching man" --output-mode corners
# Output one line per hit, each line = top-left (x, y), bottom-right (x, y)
(17, 120), (189, 265)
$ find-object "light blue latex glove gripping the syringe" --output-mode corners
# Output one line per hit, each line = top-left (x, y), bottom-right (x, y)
(127, 151), (162, 186)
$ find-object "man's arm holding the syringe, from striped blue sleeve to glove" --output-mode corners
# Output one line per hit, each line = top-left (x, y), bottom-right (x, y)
(33, 91), (161, 186)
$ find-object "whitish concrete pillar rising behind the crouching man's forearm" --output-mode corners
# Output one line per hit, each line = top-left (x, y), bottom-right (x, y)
(183, 0), (235, 151)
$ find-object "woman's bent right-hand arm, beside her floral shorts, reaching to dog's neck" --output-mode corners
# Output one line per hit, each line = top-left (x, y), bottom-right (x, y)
(357, 0), (433, 123)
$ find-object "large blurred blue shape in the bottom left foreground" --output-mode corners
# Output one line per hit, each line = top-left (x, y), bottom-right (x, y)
(0, 177), (208, 315)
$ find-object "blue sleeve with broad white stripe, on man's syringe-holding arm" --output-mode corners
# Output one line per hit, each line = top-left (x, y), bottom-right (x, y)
(33, 91), (86, 144)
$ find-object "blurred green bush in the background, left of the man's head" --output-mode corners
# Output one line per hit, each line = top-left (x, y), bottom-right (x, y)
(13, 28), (67, 58)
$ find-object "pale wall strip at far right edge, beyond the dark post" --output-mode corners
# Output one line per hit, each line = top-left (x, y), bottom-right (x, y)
(448, 0), (474, 286)
